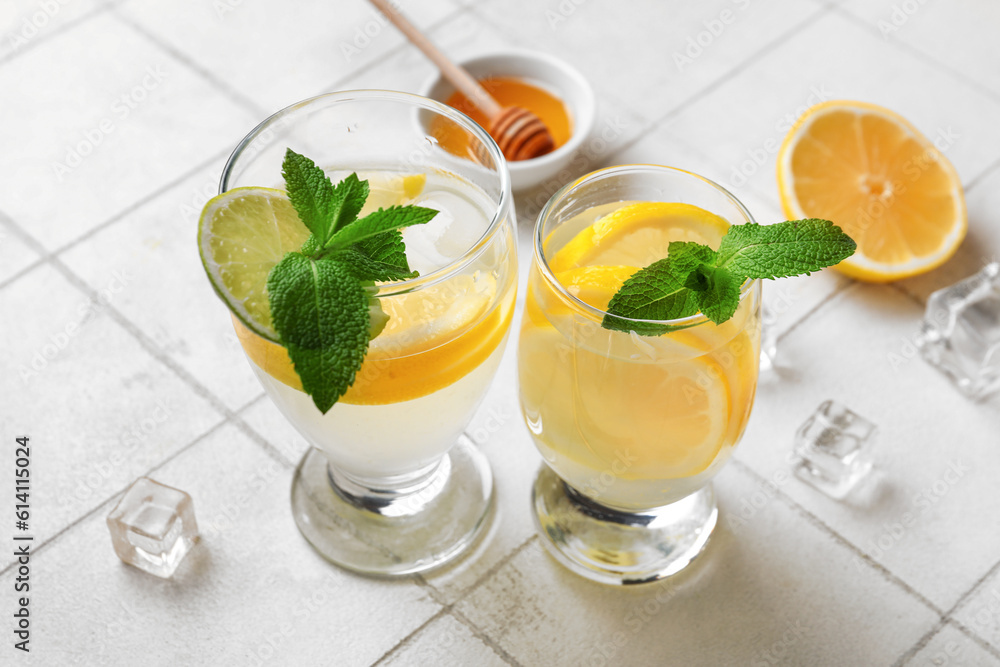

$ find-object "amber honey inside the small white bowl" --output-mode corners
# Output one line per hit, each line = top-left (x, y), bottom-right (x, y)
(431, 77), (573, 162)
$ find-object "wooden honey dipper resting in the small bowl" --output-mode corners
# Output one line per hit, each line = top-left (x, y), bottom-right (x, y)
(369, 0), (555, 160)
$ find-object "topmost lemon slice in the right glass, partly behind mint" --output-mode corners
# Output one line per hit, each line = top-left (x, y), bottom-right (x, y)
(549, 202), (729, 273)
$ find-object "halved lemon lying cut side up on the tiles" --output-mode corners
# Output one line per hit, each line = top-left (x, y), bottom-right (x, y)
(778, 100), (967, 282)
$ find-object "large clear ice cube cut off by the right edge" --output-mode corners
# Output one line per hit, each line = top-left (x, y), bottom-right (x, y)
(917, 262), (1000, 399)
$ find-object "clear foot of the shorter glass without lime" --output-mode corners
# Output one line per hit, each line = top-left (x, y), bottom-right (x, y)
(532, 465), (719, 585)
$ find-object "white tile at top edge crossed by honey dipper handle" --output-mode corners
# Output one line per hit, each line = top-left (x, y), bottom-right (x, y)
(121, 0), (458, 114)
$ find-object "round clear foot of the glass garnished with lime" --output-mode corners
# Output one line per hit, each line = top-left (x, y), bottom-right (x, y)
(292, 441), (493, 576)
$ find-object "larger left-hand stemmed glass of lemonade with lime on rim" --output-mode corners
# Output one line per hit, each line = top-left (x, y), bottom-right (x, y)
(221, 91), (517, 575)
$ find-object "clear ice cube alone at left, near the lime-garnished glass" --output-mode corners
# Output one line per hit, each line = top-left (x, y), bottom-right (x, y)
(108, 477), (198, 578)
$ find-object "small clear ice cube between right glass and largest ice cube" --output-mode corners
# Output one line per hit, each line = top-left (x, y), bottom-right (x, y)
(793, 401), (877, 498)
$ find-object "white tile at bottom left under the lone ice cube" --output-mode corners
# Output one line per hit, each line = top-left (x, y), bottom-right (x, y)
(2, 426), (440, 665)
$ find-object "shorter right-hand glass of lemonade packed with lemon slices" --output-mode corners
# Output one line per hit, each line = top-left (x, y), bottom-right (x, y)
(518, 165), (761, 584)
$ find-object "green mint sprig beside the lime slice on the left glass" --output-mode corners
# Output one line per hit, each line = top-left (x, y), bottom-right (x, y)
(267, 149), (437, 414)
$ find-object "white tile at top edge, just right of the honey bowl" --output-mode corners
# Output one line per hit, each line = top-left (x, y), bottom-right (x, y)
(475, 0), (820, 119)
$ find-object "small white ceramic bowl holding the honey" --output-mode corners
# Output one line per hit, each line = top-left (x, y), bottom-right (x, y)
(420, 51), (596, 190)
